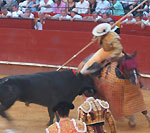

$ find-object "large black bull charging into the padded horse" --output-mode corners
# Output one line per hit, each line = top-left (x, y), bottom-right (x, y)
(0, 70), (94, 124)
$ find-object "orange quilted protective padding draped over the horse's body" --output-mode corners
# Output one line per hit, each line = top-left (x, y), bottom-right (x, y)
(95, 62), (146, 120)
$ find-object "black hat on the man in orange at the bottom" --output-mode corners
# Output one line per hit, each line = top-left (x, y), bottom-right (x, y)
(53, 101), (74, 112)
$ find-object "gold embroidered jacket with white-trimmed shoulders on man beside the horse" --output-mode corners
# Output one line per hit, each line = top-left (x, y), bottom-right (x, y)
(78, 97), (116, 133)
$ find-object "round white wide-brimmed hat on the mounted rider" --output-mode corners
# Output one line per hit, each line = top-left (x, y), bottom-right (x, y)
(92, 23), (111, 36)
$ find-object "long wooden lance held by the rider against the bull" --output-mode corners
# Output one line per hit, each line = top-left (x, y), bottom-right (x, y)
(56, 0), (147, 71)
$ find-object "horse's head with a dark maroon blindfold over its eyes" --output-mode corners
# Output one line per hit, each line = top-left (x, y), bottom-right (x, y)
(119, 52), (138, 84)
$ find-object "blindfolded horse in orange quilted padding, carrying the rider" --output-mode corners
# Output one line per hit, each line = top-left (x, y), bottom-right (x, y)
(78, 52), (150, 127)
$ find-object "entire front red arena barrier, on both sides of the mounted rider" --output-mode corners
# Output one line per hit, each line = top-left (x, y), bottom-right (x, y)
(0, 28), (150, 73)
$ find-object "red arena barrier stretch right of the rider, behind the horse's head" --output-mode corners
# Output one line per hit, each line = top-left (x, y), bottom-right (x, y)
(121, 34), (150, 74)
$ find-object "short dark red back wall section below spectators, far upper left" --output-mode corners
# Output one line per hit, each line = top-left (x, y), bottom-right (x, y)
(0, 18), (34, 29)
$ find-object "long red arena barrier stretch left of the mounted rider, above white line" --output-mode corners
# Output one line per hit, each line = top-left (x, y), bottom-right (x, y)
(0, 29), (98, 66)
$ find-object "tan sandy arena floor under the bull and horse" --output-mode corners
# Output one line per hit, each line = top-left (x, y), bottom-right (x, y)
(0, 75), (150, 133)
